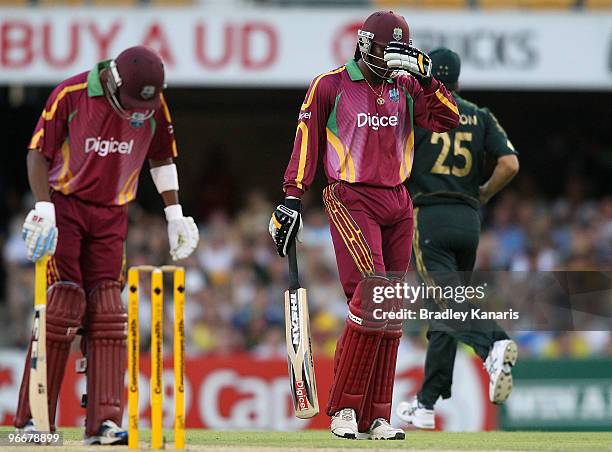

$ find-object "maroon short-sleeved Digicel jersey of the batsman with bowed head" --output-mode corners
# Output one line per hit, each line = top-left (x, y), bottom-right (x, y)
(29, 61), (177, 206)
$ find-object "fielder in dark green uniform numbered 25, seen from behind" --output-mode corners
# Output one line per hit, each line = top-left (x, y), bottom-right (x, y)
(397, 48), (519, 428)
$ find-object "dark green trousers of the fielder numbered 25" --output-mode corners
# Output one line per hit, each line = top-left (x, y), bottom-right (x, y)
(413, 204), (508, 408)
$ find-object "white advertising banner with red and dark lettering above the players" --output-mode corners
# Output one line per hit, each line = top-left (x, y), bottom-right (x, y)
(0, 8), (612, 90)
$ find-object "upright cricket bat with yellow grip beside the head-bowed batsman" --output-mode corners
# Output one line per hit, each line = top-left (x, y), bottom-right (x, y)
(29, 256), (49, 432)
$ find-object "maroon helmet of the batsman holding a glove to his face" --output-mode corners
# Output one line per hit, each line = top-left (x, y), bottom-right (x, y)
(355, 11), (410, 77)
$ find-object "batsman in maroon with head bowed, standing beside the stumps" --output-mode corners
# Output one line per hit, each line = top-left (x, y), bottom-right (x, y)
(15, 46), (199, 444)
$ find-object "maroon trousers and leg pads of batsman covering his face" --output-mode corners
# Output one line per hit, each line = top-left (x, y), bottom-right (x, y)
(323, 182), (413, 432)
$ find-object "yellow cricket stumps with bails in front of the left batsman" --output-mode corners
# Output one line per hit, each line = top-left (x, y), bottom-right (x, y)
(127, 265), (185, 449)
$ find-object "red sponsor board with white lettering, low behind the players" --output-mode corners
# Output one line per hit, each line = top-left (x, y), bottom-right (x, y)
(0, 349), (496, 431)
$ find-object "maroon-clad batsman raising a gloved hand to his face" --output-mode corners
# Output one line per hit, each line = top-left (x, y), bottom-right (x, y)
(270, 11), (459, 439)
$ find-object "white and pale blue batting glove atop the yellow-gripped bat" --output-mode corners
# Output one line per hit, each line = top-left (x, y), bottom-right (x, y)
(21, 201), (57, 262)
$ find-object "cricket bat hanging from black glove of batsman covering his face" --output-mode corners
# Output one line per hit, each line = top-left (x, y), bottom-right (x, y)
(285, 242), (319, 419)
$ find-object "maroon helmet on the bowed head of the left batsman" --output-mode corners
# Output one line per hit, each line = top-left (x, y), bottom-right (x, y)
(107, 46), (165, 119)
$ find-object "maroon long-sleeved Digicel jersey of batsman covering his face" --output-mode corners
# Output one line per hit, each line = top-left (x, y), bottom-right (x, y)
(284, 60), (459, 196)
